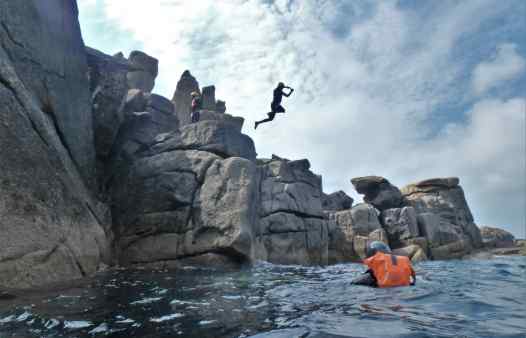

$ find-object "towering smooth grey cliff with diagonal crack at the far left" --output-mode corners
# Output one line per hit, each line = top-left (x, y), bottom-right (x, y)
(0, 0), (109, 288)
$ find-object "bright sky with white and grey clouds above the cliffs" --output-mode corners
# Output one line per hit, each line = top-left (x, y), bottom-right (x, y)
(78, 0), (526, 238)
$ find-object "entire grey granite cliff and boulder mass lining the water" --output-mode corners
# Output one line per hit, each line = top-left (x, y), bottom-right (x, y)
(0, 0), (524, 288)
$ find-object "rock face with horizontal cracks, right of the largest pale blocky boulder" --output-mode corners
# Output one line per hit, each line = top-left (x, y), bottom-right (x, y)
(255, 157), (328, 264)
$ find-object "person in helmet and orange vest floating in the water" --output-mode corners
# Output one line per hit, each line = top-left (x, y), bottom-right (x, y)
(351, 241), (416, 288)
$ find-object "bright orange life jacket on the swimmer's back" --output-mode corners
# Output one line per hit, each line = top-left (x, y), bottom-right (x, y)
(364, 252), (415, 288)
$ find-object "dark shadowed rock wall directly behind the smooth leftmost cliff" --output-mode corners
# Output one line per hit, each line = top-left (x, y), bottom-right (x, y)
(86, 48), (169, 194)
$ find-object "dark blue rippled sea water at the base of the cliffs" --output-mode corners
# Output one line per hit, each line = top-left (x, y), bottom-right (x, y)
(0, 257), (526, 338)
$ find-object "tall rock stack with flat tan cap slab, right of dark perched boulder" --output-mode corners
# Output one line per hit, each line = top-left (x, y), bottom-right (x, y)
(402, 177), (482, 258)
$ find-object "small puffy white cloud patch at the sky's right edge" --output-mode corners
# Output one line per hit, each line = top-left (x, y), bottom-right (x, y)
(472, 43), (526, 95)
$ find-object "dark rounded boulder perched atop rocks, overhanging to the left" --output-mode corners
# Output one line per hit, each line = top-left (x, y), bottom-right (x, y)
(351, 176), (403, 210)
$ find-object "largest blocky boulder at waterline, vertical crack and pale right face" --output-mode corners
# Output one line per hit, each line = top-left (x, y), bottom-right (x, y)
(114, 150), (257, 264)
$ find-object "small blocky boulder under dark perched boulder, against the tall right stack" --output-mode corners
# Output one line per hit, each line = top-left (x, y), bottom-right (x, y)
(380, 207), (419, 248)
